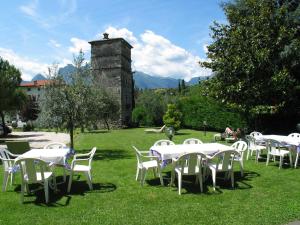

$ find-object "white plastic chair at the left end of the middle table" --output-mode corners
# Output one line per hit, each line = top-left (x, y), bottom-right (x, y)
(132, 146), (164, 186)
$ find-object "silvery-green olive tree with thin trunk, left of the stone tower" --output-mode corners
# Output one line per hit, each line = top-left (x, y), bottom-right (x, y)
(38, 52), (118, 148)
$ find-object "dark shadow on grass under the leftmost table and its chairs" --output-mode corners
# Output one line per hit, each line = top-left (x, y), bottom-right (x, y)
(15, 175), (117, 207)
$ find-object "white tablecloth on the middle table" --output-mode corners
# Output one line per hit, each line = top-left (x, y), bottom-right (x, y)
(150, 143), (234, 160)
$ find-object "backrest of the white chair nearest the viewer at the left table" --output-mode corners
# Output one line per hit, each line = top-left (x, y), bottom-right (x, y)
(16, 158), (48, 184)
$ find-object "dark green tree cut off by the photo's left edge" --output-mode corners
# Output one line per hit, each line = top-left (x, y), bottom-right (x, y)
(0, 57), (26, 135)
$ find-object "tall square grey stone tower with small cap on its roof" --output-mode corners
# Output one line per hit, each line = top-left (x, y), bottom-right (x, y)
(89, 33), (133, 127)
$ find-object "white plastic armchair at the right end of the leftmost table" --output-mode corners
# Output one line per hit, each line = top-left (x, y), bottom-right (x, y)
(68, 147), (97, 192)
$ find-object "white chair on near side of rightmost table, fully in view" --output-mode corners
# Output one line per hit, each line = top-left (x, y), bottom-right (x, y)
(266, 139), (293, 169)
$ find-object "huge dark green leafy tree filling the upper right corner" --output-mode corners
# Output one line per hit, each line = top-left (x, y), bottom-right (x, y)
(201, 0), (300, 129)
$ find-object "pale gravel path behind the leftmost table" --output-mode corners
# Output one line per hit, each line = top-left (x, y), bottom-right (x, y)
(0, 131), (70, 148)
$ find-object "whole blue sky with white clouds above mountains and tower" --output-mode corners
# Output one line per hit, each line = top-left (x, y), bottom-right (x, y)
(0, 0), (225, 80)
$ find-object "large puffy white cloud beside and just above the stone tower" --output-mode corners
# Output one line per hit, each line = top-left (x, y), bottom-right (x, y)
(105, 26), (211, 81)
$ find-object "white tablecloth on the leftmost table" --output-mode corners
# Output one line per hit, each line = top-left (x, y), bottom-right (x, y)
(15, 148), (71, 166)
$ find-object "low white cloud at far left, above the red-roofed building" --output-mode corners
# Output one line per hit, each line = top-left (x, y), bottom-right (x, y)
(0, 47), (49, 80)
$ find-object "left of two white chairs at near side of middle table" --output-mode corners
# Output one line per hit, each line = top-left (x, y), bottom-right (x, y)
(171, 153), (206, 195)
